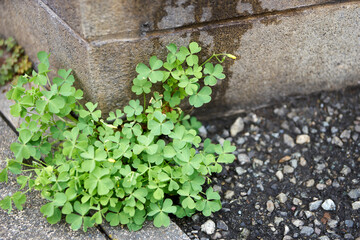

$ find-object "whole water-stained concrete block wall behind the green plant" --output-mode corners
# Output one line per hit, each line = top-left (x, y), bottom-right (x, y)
(0, 0), (360, 117)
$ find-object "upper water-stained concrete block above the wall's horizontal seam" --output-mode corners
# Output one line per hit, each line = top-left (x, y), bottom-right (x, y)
(42, 0), (331, 39)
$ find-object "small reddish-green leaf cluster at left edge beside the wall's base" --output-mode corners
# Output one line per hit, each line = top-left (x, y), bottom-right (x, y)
(0, 37), (32, 86)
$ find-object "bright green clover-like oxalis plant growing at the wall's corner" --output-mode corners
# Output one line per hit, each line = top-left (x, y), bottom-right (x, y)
(0, 42), (235, 231)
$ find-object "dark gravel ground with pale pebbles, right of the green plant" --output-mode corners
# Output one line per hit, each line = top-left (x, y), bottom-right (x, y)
(173, 87), (360, 240)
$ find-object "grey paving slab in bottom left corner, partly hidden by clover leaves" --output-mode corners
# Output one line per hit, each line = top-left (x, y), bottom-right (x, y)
(0, 117), (106, 240)
